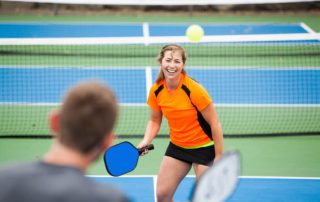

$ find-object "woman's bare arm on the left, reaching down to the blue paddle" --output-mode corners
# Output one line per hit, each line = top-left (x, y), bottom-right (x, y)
(138, 109), (162, 148)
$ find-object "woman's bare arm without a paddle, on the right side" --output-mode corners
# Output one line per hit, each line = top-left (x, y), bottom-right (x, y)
(201, 104), (223, 161)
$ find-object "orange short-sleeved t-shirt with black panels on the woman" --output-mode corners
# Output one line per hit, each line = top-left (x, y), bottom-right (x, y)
(147, 74), (212, 148)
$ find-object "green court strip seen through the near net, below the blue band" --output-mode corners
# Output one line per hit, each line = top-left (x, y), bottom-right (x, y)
(0, 105), (320, 137)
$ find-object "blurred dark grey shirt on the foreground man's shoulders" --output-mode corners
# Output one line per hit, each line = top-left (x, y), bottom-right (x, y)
(0, 162), (128, 202)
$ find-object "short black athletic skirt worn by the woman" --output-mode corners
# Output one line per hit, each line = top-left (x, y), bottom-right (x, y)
(165, 142), (215, 165)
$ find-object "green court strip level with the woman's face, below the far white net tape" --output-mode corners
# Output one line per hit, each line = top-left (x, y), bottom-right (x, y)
(0, 44), (320, 68)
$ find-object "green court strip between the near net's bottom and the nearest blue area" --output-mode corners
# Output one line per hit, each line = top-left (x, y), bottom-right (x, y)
(0, 136), (320, 177)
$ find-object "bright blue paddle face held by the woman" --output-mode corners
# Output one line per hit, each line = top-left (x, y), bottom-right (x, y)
(104, 142), (139, 176)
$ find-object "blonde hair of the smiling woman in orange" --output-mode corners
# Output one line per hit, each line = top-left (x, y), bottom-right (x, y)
(156, 44), (187, 83)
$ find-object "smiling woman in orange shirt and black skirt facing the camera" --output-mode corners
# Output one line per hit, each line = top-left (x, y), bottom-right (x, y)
(138, 44), (223, 202)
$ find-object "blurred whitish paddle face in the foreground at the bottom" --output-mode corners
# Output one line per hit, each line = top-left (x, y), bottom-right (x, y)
(192, 151), (240, 202)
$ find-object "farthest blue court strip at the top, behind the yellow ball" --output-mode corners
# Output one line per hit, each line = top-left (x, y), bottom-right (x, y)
(0, 22), (308, 38)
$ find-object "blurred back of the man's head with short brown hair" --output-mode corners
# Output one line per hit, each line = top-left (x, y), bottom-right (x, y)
(51, 82), (118, 154)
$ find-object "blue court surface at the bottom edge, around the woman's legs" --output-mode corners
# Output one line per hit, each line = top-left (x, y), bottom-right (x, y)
(91, 176), (320, 202)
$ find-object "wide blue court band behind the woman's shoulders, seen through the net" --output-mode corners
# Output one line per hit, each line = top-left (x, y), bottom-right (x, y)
(0, 67), (320, 104)
